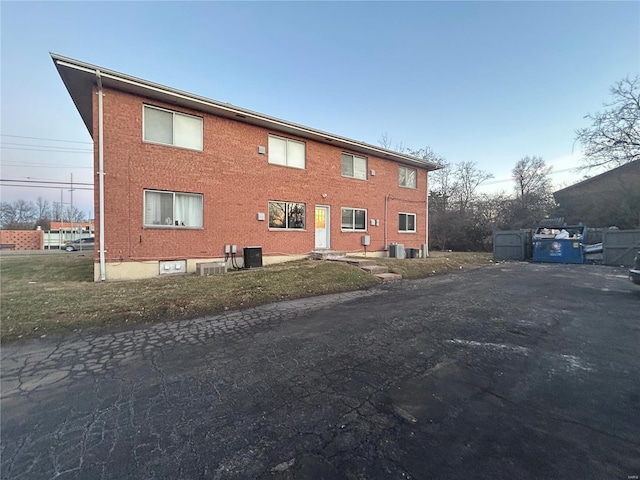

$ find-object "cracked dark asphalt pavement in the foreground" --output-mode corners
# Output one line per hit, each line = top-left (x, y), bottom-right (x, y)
(0, 263), (640, 480)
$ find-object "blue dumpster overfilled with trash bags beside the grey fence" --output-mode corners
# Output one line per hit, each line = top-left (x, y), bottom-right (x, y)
(533, 225), (587, 263)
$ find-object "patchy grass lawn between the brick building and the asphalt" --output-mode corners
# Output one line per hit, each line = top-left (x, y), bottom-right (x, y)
(0, 252), (491, 343)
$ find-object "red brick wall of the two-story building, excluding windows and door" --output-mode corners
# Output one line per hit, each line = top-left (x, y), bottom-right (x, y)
(94, 90), (427, 261)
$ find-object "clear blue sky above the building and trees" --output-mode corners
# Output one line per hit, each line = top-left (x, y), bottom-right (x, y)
(0, 1), (640, 215)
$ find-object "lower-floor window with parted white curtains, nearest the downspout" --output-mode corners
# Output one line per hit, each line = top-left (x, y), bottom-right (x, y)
(144, 190), (203, 228)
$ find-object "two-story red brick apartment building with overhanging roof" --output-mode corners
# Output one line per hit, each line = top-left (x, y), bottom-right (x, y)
(52, 54), (437, 281)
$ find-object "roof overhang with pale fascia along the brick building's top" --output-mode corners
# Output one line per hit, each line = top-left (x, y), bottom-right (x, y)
(51, 53), (441, 171)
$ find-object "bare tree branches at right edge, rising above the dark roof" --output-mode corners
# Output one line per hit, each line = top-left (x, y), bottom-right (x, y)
(576, 76), (640, 170)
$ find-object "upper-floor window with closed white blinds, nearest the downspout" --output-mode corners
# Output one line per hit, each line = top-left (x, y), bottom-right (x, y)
(143, 105), (203, 151)
